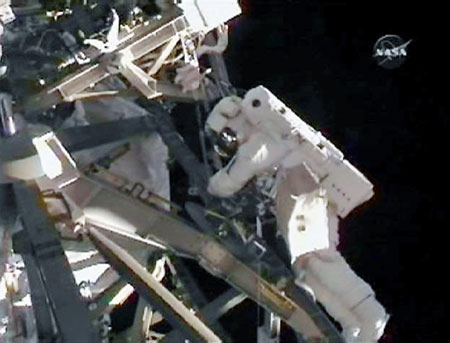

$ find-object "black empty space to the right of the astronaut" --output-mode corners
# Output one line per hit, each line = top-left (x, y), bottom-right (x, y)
(220, 0), (449, 343)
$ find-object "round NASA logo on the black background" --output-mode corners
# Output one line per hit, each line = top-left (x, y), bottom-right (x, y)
(373, 35), (412, 69)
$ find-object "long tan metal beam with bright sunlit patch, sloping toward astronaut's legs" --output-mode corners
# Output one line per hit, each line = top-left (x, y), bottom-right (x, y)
(63, 176), (322, 337)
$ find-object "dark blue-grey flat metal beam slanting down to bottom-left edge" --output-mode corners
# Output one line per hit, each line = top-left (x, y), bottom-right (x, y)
(13, 184), (97, 343)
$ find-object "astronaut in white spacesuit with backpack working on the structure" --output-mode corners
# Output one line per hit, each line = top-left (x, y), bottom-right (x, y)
(206, 86), (388, 343)
